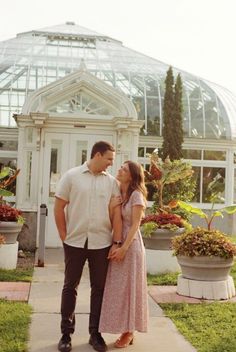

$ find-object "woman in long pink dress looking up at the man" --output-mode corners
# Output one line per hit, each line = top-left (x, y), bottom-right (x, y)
(99, 161), (147, 348)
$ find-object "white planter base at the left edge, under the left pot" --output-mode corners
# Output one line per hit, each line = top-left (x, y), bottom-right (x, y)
(0, 241), (19, 269)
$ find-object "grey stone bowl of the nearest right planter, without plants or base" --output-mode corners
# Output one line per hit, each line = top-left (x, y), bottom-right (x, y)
(177, 255), (234, 281)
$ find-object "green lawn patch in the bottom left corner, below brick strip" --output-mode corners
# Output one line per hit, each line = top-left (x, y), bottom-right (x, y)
(0, 300), (32, 352)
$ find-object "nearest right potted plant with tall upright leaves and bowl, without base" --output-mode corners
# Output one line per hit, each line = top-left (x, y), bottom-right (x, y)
(172, 175), (236, 281)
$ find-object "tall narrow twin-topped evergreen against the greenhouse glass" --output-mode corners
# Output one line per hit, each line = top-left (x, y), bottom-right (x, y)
(161, 66), (183, 160)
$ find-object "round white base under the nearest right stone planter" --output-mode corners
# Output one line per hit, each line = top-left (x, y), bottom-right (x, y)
(177, 275), (235, 300)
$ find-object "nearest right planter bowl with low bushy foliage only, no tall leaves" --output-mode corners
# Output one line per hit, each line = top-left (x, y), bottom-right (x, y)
(172, 227), (236, 281)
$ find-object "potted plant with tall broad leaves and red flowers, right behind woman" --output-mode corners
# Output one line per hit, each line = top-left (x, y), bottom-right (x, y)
(141, 152), (193, 250)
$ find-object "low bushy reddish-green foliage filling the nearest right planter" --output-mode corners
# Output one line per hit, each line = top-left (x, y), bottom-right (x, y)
(172, 227), (236, 259)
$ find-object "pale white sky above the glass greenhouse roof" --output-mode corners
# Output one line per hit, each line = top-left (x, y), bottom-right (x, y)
(0, 0), (236, 96)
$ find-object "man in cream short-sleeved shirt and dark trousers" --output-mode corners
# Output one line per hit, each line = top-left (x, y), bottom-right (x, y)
(54, 141), (122, 352)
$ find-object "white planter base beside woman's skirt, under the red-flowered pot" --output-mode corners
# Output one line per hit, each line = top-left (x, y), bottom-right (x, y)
(146, 249), (181, 275)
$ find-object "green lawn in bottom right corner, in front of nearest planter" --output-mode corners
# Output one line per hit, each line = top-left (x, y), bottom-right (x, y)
(160, 302), (236, 352)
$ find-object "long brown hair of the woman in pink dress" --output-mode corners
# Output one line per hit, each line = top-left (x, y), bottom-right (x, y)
(123, 160), (147, 205)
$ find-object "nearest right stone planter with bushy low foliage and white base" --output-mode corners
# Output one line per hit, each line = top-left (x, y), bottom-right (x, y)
(172, 227), (236, 300)
